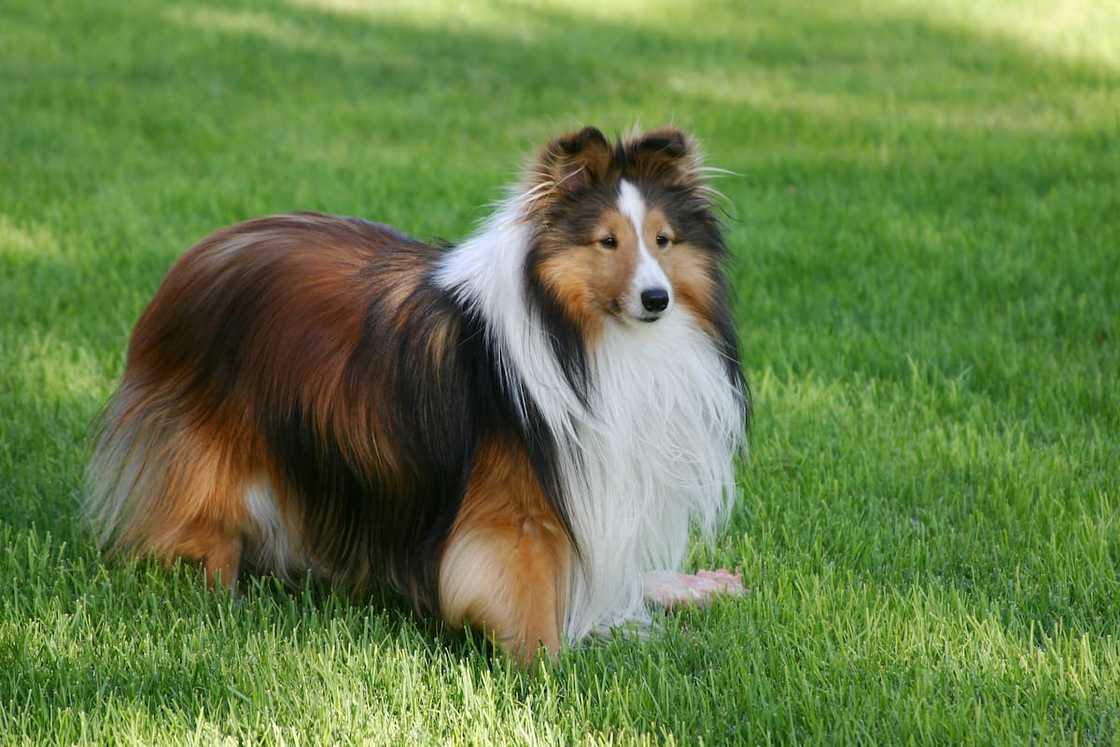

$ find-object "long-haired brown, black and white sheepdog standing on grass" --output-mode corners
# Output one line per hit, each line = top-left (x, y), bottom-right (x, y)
(85, 128), (749, 662)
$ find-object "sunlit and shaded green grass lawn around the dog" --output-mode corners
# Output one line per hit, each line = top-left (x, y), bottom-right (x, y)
(0, 0), (1120, 745)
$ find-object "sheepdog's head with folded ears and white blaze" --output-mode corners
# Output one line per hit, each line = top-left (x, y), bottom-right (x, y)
(526, 128), (722, 334)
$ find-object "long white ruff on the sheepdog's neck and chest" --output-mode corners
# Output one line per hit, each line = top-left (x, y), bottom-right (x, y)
(437, 190), (744, 642)
